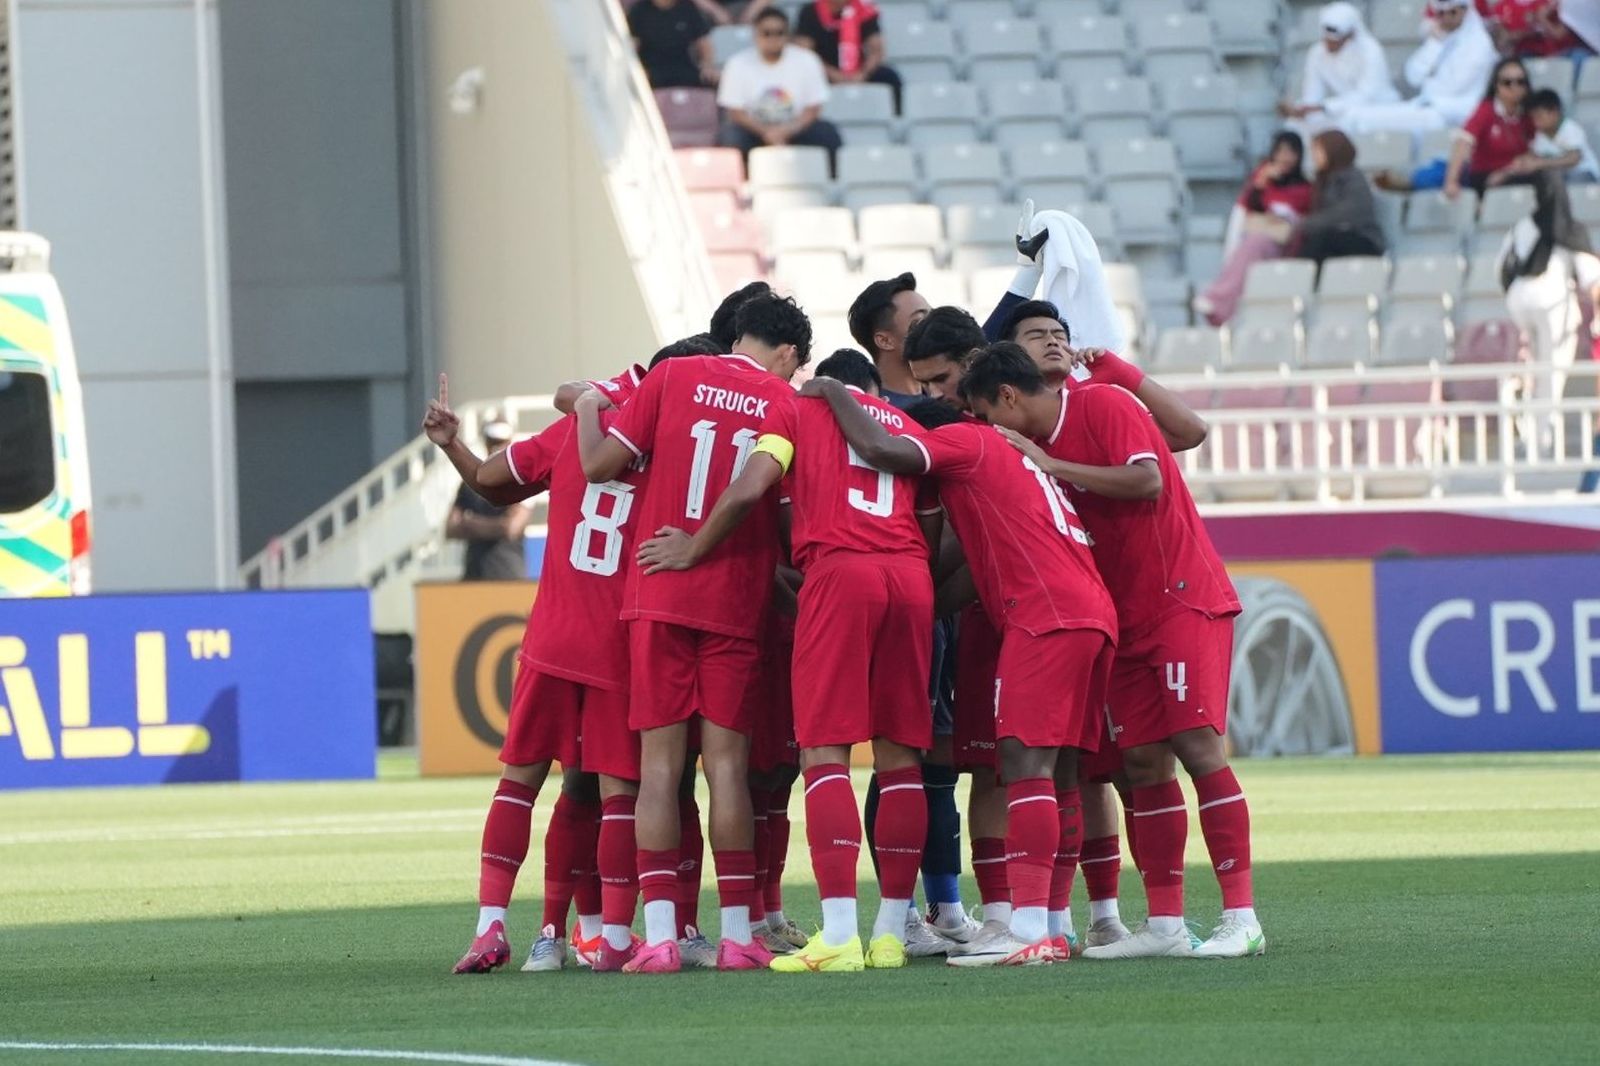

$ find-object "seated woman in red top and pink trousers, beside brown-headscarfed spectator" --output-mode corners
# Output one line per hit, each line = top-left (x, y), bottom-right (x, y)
(1194, 131), (1312, 327)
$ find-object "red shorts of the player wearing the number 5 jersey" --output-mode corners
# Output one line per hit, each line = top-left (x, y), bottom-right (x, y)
(794, 552), (933, 751)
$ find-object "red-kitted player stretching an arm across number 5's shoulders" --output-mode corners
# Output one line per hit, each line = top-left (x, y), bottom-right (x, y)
(802, 378), (1117, 967)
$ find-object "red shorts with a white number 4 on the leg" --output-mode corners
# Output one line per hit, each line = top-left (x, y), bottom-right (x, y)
(1110, 610), (1234, 749)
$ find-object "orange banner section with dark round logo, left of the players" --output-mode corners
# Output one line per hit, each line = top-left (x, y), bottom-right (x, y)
(414, 581), (539, 775)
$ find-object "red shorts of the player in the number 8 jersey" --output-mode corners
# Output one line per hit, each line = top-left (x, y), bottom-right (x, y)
(501, 663), (638, 781)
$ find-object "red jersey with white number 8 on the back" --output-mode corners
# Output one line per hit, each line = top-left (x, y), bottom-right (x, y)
(506, 411), (645, 691)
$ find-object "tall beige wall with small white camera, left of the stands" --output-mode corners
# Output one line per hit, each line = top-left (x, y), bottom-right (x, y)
(422, 0), (658, 400)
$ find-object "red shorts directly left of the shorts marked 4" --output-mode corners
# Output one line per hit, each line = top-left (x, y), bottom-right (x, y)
(995, 627), (1115, 751)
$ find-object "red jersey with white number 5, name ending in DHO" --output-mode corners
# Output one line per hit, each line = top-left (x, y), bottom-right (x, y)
(755, 391), (928, 571)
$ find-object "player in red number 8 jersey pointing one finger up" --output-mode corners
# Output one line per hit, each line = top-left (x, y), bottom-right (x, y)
(424, 364), (656, 973)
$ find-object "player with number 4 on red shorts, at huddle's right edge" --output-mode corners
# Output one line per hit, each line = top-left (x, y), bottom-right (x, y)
(963, 343), (1266, 959)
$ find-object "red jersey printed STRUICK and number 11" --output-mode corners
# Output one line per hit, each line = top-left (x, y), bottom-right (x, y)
(610, 355), (794, 639)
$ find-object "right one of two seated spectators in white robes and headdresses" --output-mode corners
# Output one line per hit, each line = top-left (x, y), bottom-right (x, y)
(1342, 0), (1499, 138)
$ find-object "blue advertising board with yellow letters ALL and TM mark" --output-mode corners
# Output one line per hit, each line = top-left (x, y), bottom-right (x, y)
(0, 589), (376, 789)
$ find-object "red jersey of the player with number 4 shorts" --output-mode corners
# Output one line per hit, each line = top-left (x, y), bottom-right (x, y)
(1042, 384), (1238, 639)
